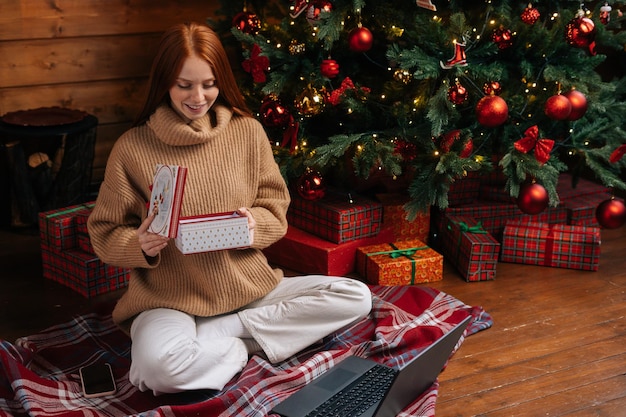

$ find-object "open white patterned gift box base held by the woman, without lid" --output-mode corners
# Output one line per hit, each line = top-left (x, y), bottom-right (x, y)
(176, 213), (250, 254)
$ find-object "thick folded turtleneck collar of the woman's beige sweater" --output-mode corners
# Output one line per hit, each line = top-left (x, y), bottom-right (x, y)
(146, 103), (233, 146)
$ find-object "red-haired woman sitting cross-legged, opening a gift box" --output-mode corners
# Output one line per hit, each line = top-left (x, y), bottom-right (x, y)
(88, 23), (371, 395)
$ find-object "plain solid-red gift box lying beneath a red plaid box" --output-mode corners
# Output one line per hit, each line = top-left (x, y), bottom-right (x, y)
(263, 225), (393, 276)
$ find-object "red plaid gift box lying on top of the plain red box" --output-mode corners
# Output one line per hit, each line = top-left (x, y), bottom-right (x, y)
(287, 191), (383, 243)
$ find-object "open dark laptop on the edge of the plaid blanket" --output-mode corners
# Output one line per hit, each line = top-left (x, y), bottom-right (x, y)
(272, 316), (471, 417)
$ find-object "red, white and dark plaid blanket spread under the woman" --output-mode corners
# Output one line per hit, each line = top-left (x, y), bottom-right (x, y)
(0, 286), (493, 417)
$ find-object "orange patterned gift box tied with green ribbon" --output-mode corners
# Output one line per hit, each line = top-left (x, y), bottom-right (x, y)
(356, 239), (443, 285)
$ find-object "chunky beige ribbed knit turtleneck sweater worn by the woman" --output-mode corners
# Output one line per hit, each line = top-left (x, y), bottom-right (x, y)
(88, 105), (290, 330)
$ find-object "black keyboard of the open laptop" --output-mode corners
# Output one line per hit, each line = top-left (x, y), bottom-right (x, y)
(306, 365), (397, 417)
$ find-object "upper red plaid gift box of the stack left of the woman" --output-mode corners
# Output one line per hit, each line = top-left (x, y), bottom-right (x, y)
(39, 202), (95, 250)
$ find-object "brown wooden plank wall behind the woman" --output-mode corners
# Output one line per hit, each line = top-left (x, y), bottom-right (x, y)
(0, 0), (219, 184)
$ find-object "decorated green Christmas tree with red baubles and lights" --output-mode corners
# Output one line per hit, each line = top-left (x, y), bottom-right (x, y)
(209, 0), (626, 217)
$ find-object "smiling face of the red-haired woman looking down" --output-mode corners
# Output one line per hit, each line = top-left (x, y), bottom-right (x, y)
(169, 55), (220, 120)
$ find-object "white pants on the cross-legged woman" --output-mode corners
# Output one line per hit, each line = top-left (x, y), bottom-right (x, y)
(130, 275), (372, 395)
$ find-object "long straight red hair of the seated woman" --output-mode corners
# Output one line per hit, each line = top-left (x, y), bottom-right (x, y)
(133, 22), (252, 126)
